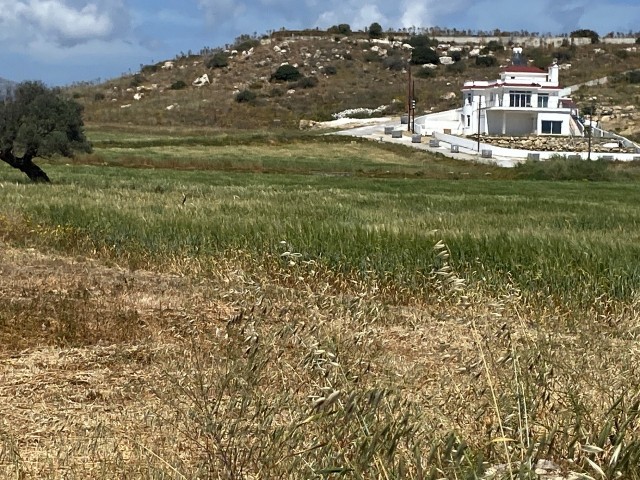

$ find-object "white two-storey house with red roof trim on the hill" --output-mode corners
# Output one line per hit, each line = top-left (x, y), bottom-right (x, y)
(460, 49), (584, 136)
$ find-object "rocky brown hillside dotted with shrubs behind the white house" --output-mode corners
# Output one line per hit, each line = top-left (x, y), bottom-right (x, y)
(66, 32), (640, 135)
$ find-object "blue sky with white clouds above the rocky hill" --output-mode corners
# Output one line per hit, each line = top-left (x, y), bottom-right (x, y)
(0, 0), (640, 86)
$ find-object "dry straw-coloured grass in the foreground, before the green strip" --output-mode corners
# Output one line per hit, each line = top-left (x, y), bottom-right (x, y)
(0, 240), (640, 479)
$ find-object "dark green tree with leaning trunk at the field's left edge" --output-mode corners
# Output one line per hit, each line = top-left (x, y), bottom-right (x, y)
(0, 82), (91, 182)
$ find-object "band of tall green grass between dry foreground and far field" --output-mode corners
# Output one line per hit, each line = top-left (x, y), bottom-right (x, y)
(0, 159), (640, 316)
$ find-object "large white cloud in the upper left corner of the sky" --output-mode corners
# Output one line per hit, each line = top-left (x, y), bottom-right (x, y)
(0, 0), (129, 47)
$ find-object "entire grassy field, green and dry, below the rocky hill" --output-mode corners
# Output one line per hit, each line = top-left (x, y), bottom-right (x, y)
(0, 130), (640, 479)
